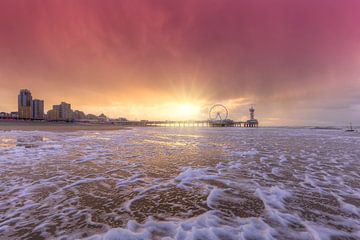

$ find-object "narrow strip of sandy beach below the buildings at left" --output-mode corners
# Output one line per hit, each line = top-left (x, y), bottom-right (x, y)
(0, 121), (127, 132)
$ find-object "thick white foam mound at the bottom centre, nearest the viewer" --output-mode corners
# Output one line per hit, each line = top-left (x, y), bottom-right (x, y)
(88, 211), (276, 240)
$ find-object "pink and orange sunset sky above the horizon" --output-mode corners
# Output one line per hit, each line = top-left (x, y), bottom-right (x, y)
(0, 0), (360, 125)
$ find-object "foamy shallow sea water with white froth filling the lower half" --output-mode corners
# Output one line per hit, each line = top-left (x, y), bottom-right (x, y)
(0, 127), (360, 240)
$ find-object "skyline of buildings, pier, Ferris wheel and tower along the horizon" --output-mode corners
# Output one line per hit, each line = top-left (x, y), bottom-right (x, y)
(0, 88), (259, 128)
